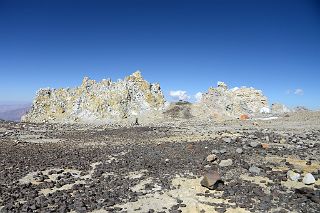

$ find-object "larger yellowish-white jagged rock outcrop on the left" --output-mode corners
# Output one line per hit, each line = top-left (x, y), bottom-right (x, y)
(22, 71), (165, 122)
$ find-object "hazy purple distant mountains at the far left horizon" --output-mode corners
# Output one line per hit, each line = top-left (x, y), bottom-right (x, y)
(0, 104), (31, 121)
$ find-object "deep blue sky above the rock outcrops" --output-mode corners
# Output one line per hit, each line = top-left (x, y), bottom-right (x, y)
(0, 0), (320, 108)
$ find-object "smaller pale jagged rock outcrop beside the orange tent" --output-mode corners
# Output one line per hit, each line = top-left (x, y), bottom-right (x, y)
(199, 82), (268, 117)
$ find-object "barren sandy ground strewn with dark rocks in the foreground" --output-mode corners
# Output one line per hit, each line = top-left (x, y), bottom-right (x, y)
(0, 112), (320, 213)
